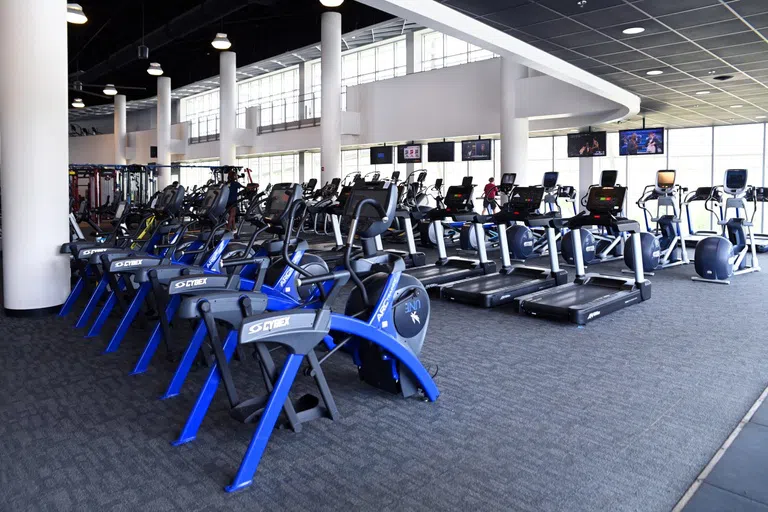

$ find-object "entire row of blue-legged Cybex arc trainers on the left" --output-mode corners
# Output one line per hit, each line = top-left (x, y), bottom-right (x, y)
(60, 178), (439, 491)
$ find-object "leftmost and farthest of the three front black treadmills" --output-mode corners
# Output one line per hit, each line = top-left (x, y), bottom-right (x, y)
(404, 181), (496, 289)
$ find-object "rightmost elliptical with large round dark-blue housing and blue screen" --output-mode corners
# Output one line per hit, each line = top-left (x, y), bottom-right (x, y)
(691, 169), (760, 284)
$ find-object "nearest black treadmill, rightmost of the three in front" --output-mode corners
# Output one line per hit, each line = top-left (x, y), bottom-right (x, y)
(513, 187), (651, 325)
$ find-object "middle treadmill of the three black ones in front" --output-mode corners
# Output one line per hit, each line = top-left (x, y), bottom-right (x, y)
(440, 187), (568, 308)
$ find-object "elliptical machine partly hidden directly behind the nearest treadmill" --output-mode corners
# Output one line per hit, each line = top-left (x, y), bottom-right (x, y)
(560, 170), (626, 265)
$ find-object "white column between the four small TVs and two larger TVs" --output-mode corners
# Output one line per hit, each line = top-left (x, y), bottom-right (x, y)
(500, 57), (529, 185)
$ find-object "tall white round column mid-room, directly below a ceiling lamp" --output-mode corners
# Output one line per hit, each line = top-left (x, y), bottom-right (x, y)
(319, 11), (341, 183)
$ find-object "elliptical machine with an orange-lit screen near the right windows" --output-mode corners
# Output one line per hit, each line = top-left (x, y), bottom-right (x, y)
(623, 170), (690, 275)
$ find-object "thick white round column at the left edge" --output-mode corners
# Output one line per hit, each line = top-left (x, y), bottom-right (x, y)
(0, 0), (70, 312)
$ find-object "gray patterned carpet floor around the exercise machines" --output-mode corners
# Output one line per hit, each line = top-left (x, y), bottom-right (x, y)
(0, 245), (768, 511)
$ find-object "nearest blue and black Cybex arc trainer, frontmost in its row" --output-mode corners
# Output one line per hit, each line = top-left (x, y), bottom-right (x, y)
(173, 182), (439, 492)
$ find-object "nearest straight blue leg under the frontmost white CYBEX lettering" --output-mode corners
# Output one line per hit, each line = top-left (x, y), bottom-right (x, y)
(224, 354), (304, 492)
